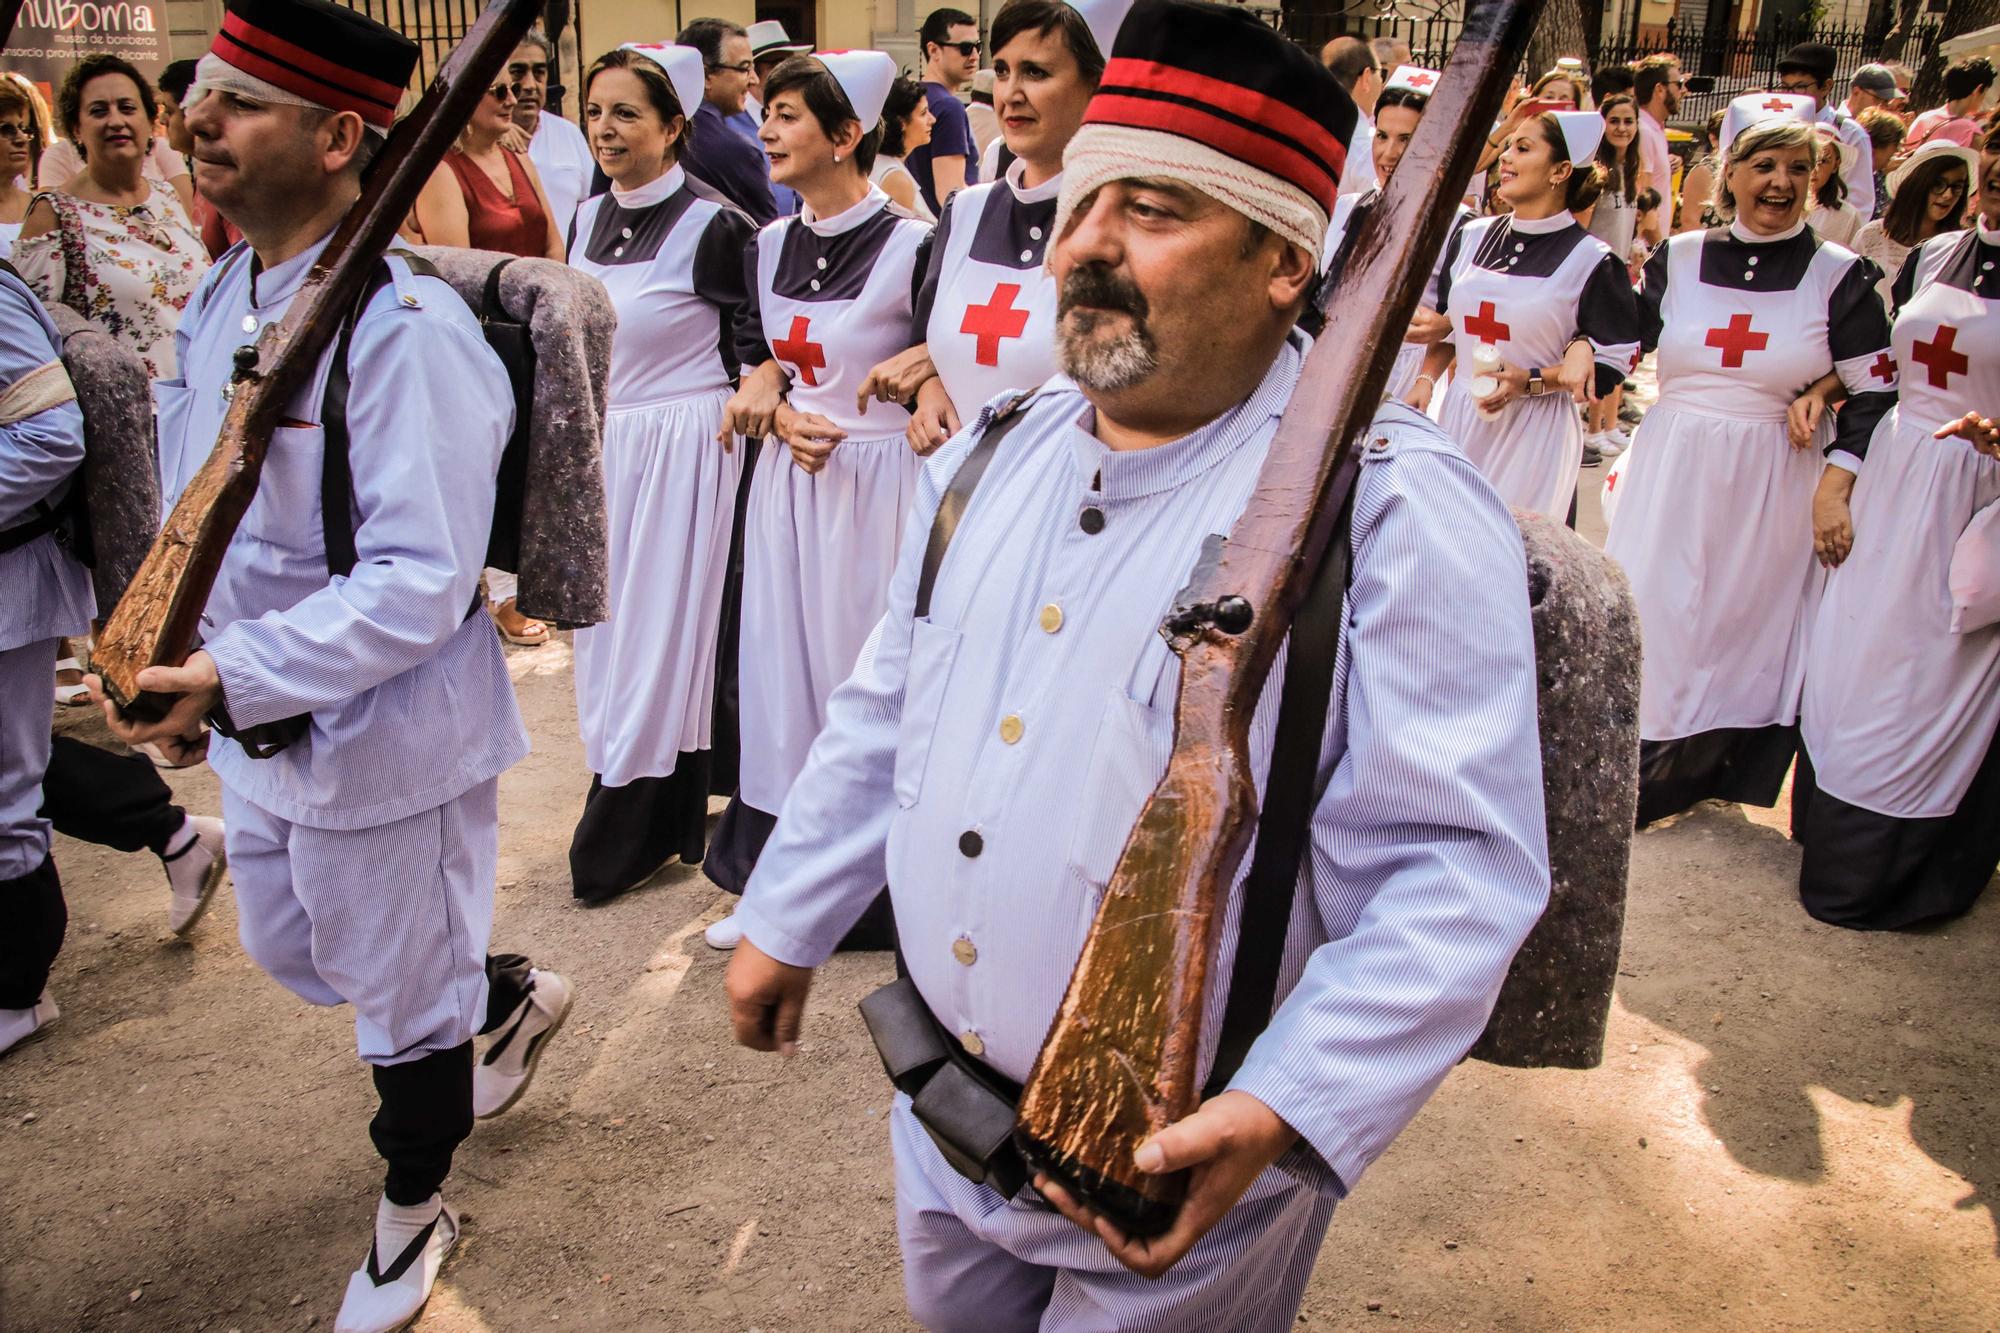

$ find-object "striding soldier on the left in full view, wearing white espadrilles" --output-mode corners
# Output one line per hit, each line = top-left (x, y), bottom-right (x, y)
(104, 0), (570, 1333)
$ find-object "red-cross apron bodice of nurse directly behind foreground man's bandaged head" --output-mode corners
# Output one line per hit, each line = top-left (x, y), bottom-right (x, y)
(914, 160), (1062, 412)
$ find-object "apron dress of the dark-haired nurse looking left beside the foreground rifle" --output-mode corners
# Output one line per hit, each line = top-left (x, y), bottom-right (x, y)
(1438, 212), (1638, 522)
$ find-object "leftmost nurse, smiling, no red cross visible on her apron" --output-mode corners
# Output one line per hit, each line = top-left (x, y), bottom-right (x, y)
(570, 46), (756, 903)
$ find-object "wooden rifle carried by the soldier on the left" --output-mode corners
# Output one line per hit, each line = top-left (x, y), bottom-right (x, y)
(92, 0), (542, 723)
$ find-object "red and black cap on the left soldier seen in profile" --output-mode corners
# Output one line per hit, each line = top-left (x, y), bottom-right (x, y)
(210, 0), (416, 130)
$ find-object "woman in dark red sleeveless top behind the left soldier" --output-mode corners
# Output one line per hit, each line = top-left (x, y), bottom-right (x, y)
(412, 74), (564, 648)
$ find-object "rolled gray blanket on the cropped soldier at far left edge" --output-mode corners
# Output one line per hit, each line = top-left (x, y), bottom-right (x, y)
(48, 306), (160, 616)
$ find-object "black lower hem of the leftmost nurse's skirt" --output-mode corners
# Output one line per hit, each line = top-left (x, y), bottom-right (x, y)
(570, 751), (710, 903)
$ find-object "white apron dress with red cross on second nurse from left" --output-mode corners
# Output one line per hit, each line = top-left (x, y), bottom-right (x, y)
(738, 188), (930, 815)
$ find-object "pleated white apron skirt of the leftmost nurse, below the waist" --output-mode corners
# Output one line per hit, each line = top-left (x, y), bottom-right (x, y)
(576, 388), (744, 787)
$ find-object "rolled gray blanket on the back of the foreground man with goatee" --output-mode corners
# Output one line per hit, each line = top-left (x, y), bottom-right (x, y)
(1470, 510), (1640, 1069)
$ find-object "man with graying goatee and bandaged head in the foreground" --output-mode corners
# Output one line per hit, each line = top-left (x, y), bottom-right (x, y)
(728, 0), (1548, 1331)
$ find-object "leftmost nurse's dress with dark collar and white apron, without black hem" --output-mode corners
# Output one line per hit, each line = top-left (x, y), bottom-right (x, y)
(564, 166), (752, 787)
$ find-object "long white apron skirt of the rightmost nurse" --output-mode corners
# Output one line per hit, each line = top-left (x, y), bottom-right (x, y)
(1802, 410), (2000, 819)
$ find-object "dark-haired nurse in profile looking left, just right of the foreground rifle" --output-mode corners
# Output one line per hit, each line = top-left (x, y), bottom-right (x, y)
(1410, 112), (1638, 522)
